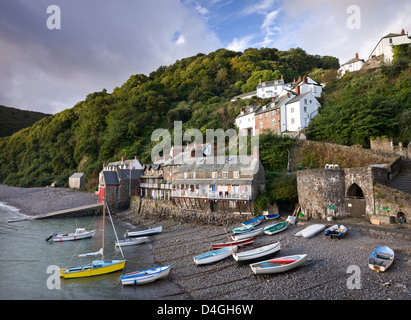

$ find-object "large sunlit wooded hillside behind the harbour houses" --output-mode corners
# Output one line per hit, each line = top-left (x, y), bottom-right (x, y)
(0, 48), (338, 189)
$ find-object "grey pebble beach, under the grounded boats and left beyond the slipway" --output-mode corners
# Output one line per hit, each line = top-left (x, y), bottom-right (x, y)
(0, 185), (411, 301)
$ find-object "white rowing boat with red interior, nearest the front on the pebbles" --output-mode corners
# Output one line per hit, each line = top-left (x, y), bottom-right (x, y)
(250, 254), (307, 274)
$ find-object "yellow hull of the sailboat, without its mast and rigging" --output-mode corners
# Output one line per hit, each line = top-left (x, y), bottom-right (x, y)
(60, 260), (126, 279)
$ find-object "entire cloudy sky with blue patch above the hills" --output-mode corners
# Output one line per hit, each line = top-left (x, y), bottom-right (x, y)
(0, 0), (411, 114)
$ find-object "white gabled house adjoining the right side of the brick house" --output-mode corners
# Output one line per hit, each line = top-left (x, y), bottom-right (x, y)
(281, 91), (321, 133)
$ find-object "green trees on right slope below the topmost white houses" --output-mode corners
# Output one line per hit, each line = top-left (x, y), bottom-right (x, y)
(307, 45), (411, 147)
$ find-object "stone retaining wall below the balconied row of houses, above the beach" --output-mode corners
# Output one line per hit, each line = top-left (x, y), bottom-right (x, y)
(130, 197), (252, 225)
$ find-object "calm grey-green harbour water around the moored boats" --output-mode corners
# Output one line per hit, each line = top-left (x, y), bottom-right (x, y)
(0, 202), (179, 300)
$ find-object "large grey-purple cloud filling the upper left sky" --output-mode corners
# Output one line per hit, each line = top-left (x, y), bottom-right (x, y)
(0, 0), (222, 113)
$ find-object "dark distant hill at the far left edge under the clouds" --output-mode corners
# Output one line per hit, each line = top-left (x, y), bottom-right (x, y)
(0, 105), (50, 137)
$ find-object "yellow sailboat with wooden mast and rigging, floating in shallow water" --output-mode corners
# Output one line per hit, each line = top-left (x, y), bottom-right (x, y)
(60, 201), (126, 279)
